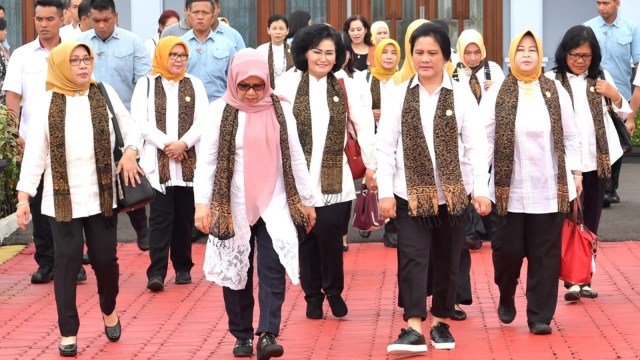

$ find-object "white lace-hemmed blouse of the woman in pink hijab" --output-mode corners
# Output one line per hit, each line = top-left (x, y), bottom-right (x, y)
(193, 98), (314, 290)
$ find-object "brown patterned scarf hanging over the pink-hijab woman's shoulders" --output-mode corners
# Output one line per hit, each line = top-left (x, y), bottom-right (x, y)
(209, 94), (309, 240)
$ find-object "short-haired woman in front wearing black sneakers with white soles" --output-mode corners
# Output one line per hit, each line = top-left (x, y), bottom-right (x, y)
(377, 23), (491, 354)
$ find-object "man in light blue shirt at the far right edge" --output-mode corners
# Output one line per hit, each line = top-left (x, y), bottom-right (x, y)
(584, 0), (640, 207)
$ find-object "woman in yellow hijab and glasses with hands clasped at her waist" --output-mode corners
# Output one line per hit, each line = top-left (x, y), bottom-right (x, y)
(131, 36), (208, 292)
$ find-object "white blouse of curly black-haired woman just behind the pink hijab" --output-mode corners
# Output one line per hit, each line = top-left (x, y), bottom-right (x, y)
(276, 71), (376, 207)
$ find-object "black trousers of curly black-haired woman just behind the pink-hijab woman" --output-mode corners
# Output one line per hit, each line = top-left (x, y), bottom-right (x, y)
(298, 201), (351, 302)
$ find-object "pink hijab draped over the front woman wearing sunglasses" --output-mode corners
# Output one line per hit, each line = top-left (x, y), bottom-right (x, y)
(222, 49), (281, 225)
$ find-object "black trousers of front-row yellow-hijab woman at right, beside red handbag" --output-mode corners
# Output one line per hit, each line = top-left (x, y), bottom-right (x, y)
(491, 212), (562, 324)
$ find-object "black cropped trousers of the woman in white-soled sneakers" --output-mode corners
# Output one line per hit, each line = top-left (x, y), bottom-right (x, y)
(396, 196), (465, 321)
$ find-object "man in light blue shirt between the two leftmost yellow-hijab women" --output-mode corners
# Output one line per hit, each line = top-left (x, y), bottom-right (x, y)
(78, 0), (151, 251)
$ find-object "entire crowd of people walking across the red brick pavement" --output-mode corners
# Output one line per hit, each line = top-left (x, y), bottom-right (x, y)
(0, 0), (640, 360)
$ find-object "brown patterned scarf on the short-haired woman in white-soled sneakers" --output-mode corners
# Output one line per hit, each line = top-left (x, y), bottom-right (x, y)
(402, 76), (469, 217)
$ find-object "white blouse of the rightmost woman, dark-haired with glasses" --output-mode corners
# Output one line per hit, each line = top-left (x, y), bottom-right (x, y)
(545, 69), (631, 172)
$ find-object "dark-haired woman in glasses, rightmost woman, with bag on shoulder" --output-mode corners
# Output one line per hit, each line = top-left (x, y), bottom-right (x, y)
(545, 25), (631, 301)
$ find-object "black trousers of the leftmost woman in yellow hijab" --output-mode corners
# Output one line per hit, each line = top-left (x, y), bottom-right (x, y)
(47, 214), (120, 336)
